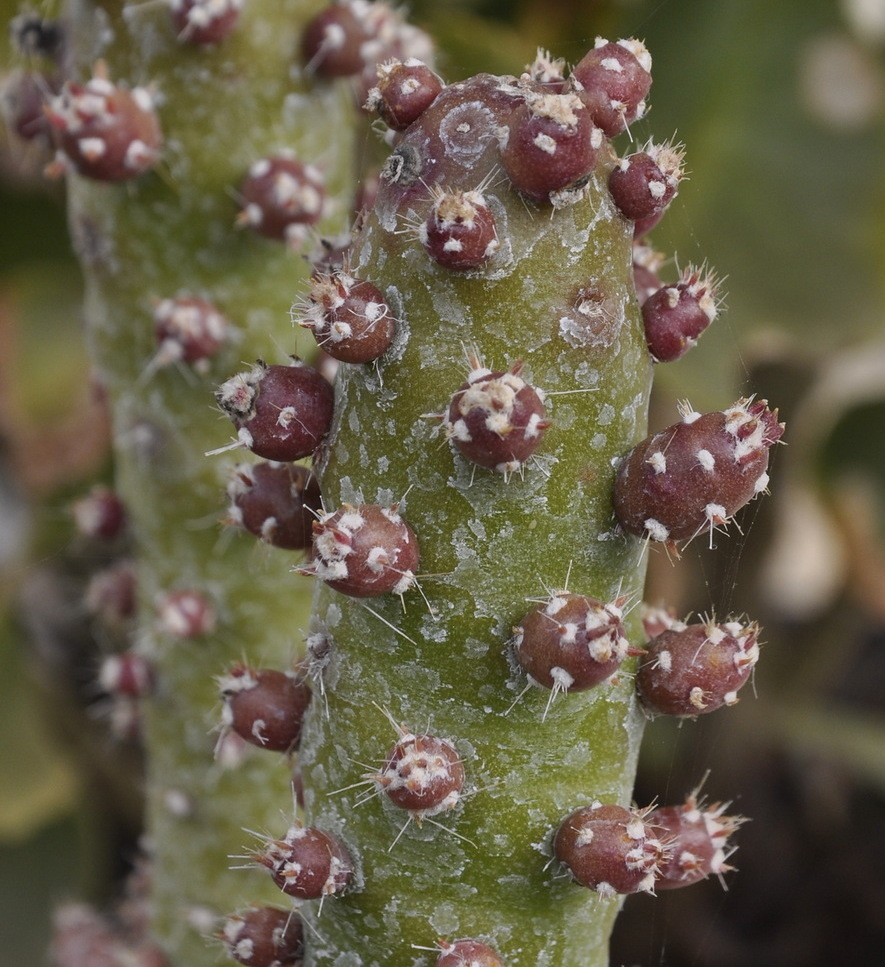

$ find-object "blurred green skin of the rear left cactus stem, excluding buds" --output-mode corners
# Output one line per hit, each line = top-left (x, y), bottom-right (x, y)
(57, 0), (355, 967)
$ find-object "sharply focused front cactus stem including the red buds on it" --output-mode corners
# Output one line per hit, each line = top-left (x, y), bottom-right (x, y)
(284, 26), (782, 965)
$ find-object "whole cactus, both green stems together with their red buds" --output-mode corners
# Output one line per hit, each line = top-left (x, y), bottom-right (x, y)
(5, 0), (782, 967)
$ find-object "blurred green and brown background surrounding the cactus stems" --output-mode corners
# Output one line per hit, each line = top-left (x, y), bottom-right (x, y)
(0, 0), (885, 967)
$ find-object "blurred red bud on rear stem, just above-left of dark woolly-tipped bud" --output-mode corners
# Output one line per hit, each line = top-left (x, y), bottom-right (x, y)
(154, 295), (229, 371)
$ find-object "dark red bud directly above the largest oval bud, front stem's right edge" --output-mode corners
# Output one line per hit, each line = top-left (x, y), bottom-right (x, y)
(642, 266), (718, 363)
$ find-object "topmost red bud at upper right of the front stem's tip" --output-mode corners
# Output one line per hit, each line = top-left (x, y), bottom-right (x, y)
(569, 37), (651, 138)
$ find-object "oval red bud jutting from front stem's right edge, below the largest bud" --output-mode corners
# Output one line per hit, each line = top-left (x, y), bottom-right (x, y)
(636, 620), (759, 716)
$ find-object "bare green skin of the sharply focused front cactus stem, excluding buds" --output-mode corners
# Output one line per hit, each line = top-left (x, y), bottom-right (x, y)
(300, 64), (652, 967)
